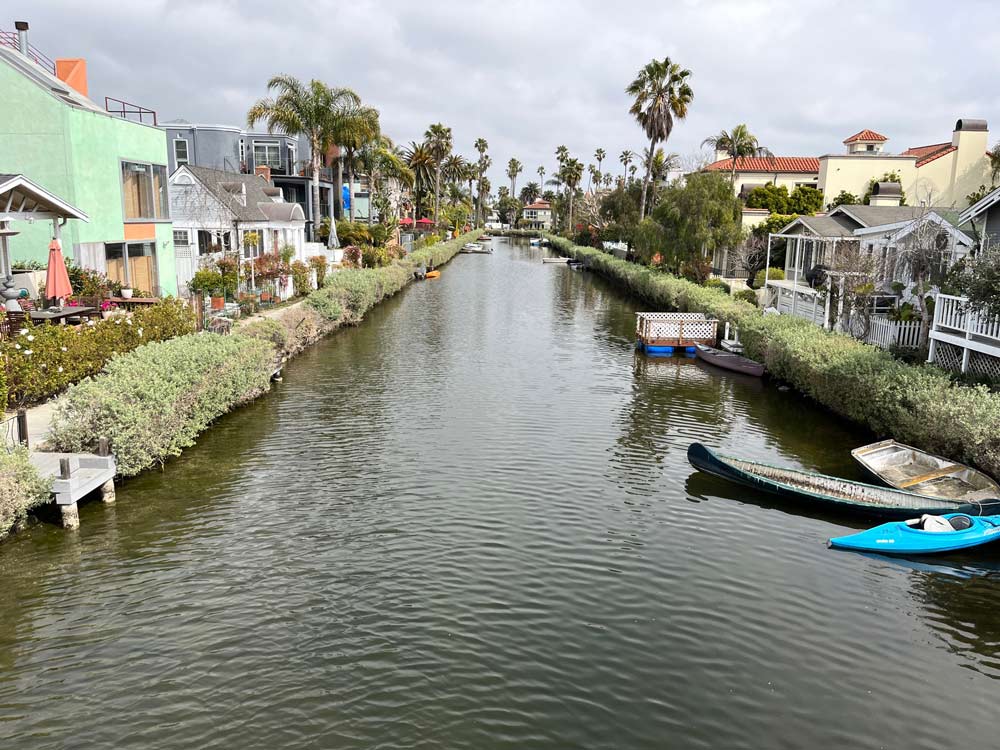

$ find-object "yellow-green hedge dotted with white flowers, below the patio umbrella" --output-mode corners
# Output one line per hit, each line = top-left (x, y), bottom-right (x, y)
(0, 298), (194, 406)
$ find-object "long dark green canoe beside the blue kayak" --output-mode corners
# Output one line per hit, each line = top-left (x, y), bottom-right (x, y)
(688, 443), (1000, 521)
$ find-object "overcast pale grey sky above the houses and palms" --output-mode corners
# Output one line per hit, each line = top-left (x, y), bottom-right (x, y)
(17, 0), (1000, 186)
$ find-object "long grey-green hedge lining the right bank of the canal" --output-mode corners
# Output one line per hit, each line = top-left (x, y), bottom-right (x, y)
(546, 235), (1000, 476)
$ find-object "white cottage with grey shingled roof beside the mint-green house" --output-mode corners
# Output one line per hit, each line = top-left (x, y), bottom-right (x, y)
(169, 164), (306, 294)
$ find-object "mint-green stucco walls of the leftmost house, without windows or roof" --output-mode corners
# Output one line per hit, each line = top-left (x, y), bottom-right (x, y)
(0, 57), (177, 294)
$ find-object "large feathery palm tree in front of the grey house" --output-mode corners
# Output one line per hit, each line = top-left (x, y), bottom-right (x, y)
(247, 75), (361, 247)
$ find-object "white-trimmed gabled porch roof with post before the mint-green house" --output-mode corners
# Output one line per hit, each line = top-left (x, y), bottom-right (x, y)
(0, 174), (90, 311)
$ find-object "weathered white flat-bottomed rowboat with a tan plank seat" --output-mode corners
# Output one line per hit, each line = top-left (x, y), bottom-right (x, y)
(851, 440), (1000, 500)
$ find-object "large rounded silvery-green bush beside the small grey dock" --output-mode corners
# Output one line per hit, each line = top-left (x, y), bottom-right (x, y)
(50, 333), (275, 476)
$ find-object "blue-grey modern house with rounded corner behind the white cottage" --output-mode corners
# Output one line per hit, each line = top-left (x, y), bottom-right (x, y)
(162, 120), (334, 235)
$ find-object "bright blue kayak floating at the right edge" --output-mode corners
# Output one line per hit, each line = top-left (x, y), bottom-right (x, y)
(829, 513), (1000, 555)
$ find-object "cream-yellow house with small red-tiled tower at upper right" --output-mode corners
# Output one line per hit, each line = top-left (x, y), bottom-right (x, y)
(818, 118), (991, 207)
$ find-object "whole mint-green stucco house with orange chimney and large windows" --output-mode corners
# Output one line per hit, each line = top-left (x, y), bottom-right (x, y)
(0, 40), (177, 296)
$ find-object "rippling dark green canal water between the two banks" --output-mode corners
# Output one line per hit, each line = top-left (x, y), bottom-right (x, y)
(0, 240), (1000, 750)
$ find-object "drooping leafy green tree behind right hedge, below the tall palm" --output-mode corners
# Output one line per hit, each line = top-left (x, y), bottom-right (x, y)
(653, 172), (743, 273)
